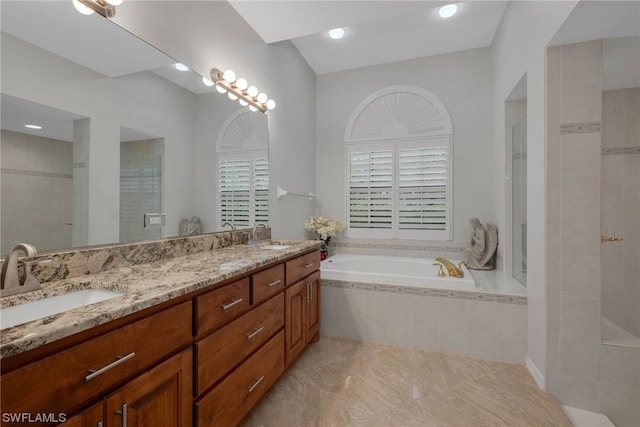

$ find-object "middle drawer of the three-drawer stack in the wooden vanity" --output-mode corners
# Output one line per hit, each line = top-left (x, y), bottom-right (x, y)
(196, 293), (284, 395)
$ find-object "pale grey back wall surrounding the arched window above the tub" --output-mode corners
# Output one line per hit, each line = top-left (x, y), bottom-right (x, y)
(316, 48), (496, 242)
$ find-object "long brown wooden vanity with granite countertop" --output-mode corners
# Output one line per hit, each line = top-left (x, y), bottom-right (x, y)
(0, 237), (320, 426)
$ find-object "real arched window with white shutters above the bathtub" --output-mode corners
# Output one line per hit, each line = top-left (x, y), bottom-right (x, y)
(345, 85), (453, 240)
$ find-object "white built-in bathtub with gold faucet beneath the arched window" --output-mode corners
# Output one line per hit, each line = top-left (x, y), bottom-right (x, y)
(320, 254), (476, 290)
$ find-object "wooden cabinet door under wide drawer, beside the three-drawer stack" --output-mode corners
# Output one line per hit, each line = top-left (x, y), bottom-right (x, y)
(105, 349), (192, 427)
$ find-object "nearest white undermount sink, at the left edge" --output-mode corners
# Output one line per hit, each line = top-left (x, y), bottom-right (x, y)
(0, 289), (122, 329)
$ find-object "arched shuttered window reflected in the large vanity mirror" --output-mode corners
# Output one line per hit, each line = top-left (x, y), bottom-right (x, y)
(216, 109), (269, 229)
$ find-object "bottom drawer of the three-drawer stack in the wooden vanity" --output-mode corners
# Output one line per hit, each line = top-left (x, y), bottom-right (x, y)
(195, 331), (284, 427)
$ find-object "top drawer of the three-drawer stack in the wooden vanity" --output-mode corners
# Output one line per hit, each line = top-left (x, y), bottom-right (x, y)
(196, 277), (250, 335)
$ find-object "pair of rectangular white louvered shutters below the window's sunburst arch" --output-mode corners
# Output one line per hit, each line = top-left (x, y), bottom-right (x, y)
(346, 137), (451, 240)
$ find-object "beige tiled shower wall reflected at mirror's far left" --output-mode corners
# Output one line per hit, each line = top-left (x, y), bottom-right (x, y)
(0, 130), (73, 255)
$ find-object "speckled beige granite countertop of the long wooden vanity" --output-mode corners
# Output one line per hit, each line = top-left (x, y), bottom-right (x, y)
(0, 240), (321, 358)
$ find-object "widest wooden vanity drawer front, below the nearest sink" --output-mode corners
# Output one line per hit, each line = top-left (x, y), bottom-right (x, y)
(1, 302), (192, 420)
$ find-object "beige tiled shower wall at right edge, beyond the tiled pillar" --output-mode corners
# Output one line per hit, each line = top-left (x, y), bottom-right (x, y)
(602, 88), (640, 337)
